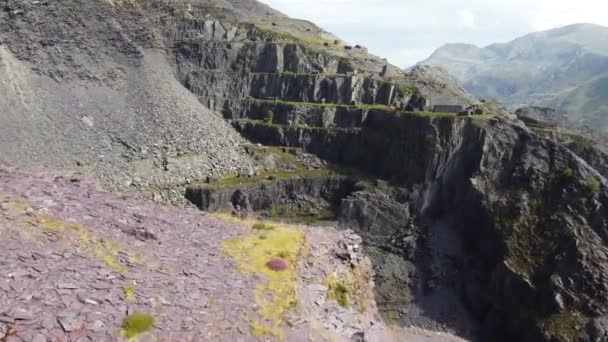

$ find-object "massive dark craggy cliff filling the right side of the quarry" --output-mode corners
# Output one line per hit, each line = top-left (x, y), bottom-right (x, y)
(340, 115), (608, 341)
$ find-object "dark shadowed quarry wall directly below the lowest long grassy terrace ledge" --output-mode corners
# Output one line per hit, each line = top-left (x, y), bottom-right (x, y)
(237, 110), (478, 196)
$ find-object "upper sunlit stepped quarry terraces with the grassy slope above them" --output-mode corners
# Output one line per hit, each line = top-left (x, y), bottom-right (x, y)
(152, 1), (475, 119)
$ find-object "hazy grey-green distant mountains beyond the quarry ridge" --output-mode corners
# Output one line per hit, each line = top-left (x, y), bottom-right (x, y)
(419, 24), (608, 132)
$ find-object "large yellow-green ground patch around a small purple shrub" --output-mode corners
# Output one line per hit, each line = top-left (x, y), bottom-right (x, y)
(222, 220), (305, 338)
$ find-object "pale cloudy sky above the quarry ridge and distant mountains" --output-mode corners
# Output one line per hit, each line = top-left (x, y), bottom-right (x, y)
(261, 0), (608, 67)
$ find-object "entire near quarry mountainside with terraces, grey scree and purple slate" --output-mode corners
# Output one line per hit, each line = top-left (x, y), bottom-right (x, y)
(0, 0), (608, 342)
